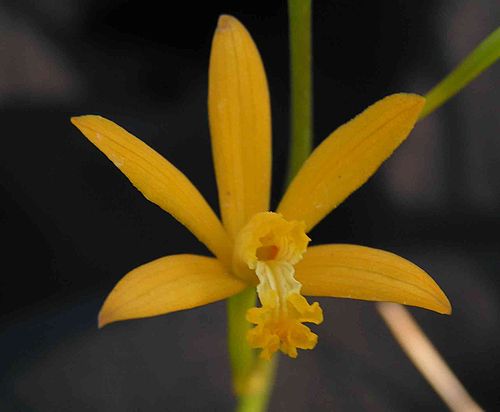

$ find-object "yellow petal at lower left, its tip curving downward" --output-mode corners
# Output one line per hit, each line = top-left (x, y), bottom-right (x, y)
(99, 255), (246, 327)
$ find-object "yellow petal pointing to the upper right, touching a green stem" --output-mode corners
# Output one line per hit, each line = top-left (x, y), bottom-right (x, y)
(278, 93), (425, 231)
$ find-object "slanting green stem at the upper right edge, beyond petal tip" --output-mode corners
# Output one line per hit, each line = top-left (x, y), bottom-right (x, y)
(420, 27), (500, 119)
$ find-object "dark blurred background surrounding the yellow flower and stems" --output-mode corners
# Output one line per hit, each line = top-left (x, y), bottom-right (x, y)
(0, 0), (500, 411)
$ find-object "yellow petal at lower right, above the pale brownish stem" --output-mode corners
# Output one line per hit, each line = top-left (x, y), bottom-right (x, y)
(296, 245), (451, 314)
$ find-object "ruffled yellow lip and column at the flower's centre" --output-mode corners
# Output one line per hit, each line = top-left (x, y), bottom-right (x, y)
(234, 212), (323, 359)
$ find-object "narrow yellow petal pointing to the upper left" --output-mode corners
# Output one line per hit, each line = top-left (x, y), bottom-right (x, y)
(71, 116), (231, 263)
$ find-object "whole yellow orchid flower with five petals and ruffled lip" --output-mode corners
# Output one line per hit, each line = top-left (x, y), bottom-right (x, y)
(71, 16), (451, 359)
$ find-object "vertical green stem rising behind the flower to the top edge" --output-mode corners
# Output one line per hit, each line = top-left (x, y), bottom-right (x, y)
(288, 0), (313, 181)
